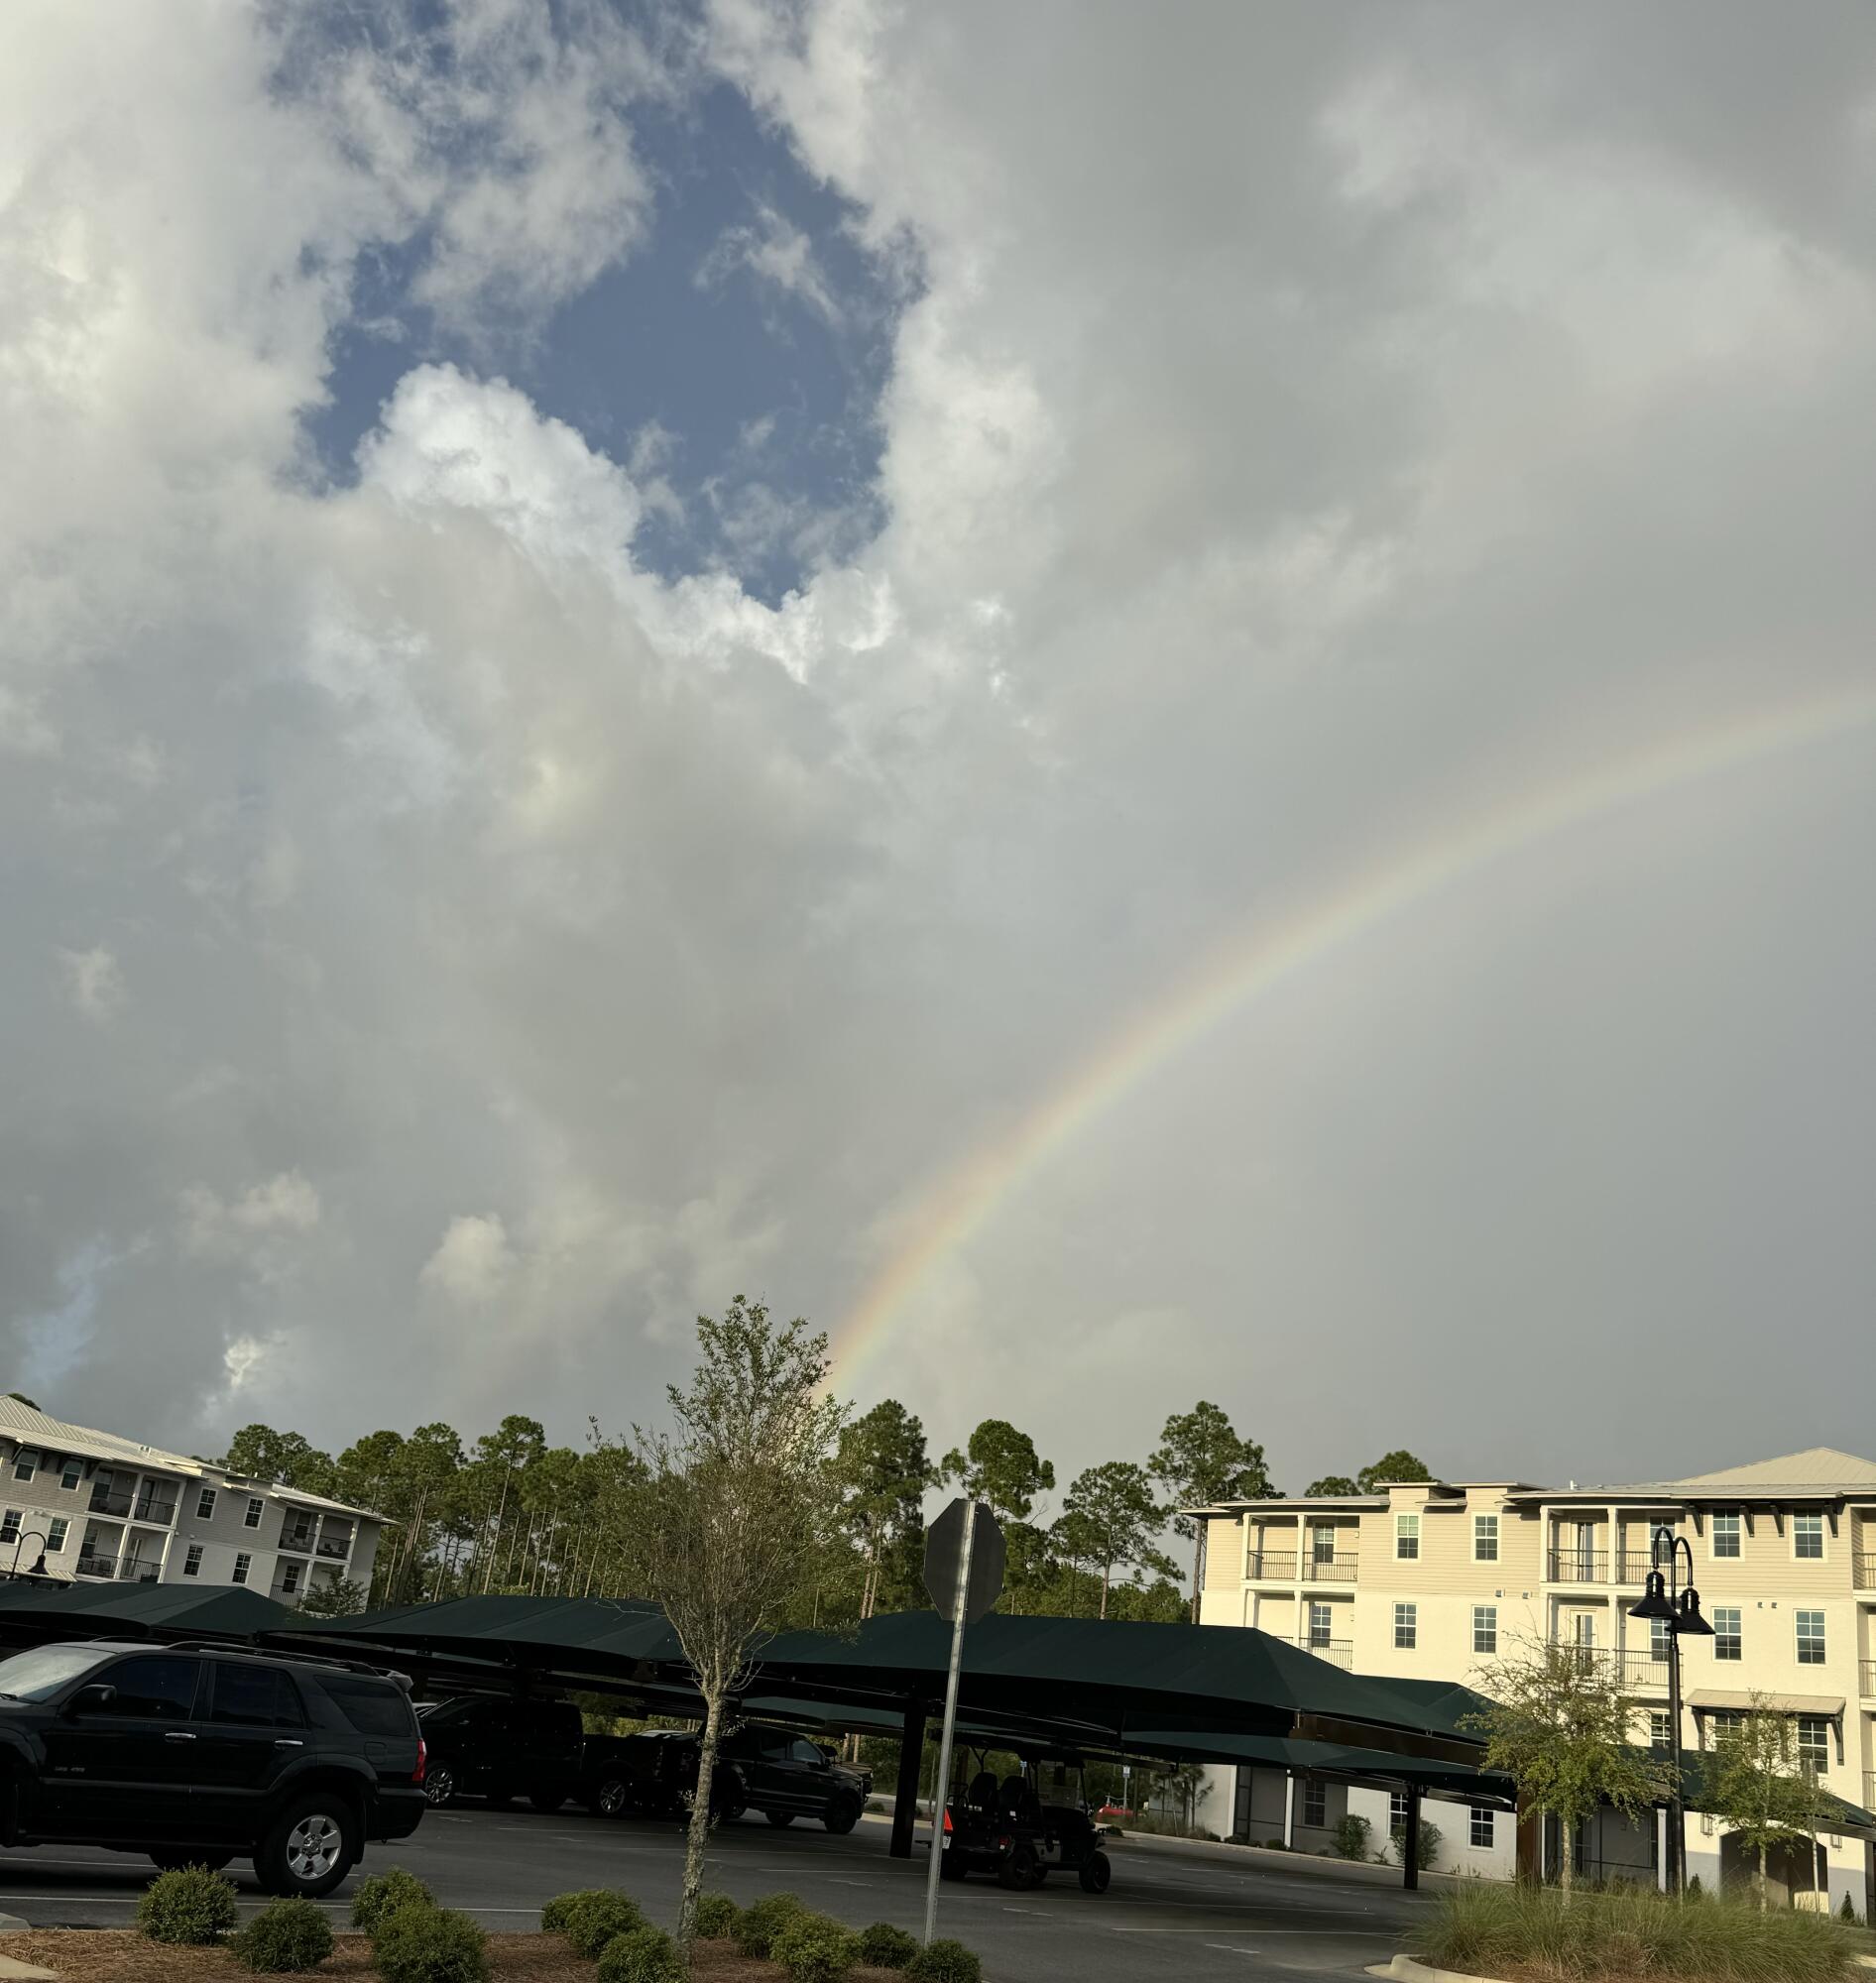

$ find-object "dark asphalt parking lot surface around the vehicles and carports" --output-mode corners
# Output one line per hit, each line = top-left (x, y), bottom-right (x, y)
(0, 1805), (1420, 1983)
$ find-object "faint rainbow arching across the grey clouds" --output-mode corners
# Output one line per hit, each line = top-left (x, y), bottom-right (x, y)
(833, 688), (1876, 1392)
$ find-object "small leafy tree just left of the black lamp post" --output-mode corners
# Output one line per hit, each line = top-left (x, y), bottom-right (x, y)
(1462, 1640), (1672, 1894)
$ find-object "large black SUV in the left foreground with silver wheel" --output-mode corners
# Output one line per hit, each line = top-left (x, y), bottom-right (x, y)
(0, 1640), (424, 1898)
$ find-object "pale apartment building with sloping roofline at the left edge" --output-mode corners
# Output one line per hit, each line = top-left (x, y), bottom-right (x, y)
(0, 1398), (385, 1606)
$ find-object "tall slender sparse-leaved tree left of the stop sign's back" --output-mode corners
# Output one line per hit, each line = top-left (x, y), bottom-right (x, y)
(633, 1295), (847, 1955)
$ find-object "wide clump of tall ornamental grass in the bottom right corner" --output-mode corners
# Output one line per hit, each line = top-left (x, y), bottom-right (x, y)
(1408, 1880), (1856, 1983)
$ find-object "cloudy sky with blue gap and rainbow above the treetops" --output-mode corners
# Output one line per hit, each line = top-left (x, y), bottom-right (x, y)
(0, 0), (1876, 1489)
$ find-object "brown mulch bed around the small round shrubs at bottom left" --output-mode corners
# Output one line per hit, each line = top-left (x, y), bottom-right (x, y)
(0, 1927), (904, 1983)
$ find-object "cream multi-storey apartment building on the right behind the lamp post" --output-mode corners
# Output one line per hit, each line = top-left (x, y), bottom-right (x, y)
(1200, 1448), (1876, 1912)
